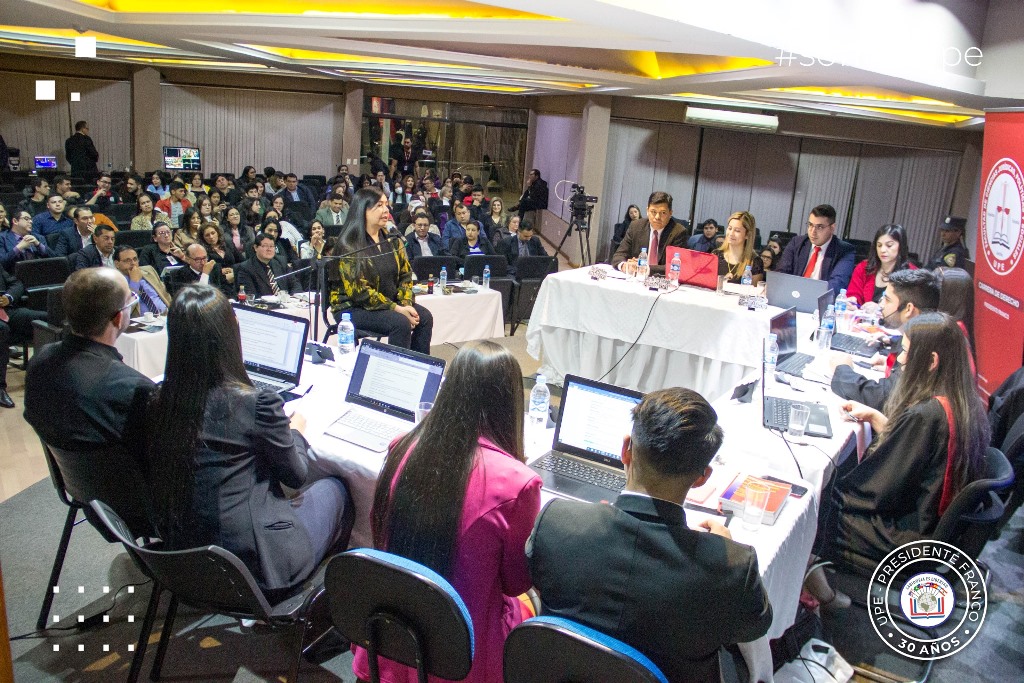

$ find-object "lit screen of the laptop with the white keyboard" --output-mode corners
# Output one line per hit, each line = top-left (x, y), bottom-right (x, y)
(345, 339), (444, 420)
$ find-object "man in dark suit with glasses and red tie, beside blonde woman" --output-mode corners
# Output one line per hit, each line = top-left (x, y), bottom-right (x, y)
(775, 204), (857, 294)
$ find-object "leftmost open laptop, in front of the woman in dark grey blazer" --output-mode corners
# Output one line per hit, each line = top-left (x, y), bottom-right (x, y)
(231, 304), (309, 393)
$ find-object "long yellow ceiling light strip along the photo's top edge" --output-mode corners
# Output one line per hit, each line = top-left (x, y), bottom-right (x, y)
(78, 0), (561, 20)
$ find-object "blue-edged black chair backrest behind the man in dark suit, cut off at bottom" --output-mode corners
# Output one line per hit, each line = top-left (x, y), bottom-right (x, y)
(504, 616), (669, 683)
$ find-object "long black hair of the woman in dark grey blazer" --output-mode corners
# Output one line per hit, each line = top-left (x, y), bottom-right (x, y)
(146, 285), (253, 540)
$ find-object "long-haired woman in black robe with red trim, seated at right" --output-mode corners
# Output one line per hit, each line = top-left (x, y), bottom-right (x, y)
(808, 312), (989, 577)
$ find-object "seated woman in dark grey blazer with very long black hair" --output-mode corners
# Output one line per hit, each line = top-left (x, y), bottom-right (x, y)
(146, 286), (352, 603)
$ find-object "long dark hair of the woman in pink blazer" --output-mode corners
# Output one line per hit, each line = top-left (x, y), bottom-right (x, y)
(371, 341), (525, 579)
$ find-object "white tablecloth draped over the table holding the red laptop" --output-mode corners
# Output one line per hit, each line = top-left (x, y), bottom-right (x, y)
(526, 268), (778, 400)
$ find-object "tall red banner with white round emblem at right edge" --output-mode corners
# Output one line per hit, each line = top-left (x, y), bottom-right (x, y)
(974, 111), (1024, 394)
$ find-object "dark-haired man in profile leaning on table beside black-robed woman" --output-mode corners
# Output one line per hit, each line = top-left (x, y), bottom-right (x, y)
(830, 268), (940, 411)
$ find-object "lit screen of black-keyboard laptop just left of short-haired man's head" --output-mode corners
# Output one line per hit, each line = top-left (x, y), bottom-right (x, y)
(554, 375), (643, 467)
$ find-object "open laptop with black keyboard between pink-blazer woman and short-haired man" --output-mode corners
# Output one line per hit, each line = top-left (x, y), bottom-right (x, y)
(530, 375), (643, 503)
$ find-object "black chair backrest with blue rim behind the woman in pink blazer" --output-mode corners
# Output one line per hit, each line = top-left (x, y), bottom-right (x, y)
(324, 548), (473, 681)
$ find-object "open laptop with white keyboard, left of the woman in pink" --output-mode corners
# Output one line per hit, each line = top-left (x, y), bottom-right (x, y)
(326, 339), (444, 453)
